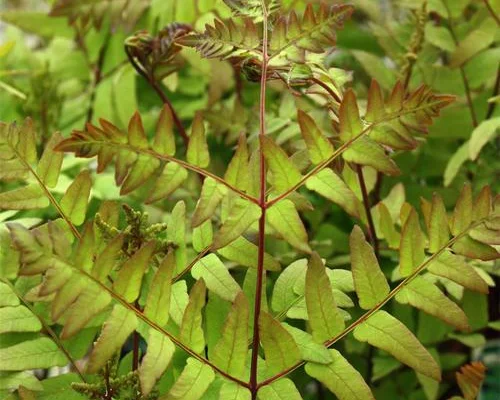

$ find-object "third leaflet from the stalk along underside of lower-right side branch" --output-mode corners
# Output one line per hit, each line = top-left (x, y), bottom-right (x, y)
(396, 276), (469, 331)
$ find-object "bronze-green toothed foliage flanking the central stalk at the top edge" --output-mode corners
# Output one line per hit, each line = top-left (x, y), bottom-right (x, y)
(179, 0), (353, 74)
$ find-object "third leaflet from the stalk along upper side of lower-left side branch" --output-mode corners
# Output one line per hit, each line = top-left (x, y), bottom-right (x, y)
(144, 251), (175, 326)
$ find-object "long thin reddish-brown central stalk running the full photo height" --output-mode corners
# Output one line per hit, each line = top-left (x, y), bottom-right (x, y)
(249, 0), (269, 400)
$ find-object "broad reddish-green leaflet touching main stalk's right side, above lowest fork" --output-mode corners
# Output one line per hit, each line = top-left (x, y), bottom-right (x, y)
(259, 312), (301, 374)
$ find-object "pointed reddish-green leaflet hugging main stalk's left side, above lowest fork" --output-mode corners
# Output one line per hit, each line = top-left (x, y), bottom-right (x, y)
(212, 291), (249, 379)
